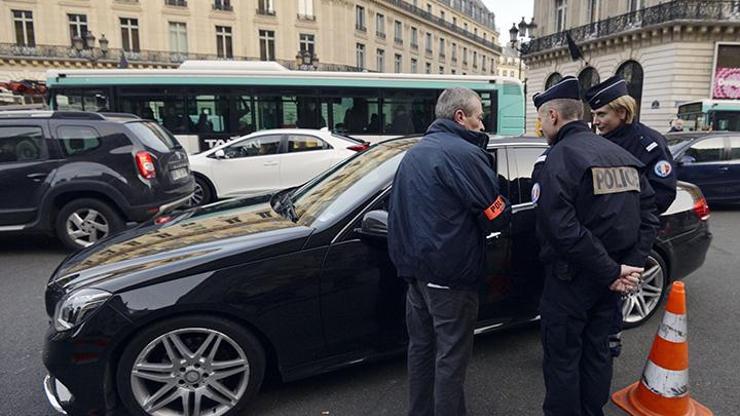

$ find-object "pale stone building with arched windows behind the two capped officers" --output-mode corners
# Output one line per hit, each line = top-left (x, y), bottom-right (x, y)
(524, 0), (740, 132)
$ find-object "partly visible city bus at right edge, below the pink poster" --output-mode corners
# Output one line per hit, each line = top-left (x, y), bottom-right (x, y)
(678, 99), (740, 131)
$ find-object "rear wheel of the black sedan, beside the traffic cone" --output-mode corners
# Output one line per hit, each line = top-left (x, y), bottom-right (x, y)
(622, 250), (669, 328)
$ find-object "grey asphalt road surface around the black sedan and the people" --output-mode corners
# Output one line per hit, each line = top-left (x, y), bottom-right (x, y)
(0, 210), (740, 416)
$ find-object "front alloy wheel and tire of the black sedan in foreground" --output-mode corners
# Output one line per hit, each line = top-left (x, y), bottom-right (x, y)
(116, 315), (266, 416)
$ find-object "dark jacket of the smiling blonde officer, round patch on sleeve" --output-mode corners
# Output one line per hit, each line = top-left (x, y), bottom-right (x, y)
(604, 123), (676, 213)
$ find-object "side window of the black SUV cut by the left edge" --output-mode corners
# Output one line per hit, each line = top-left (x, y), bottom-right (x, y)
(0, 127), (47, 163)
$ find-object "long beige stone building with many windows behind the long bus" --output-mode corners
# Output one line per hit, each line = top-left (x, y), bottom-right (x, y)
(0, 0), (501, 82)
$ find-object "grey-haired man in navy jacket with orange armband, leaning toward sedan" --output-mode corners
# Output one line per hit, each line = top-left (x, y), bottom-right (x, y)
(388, 88), (510, 416)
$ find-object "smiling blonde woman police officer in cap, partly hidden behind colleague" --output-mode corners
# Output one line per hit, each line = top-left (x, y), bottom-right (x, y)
(585, 75), (676, 357)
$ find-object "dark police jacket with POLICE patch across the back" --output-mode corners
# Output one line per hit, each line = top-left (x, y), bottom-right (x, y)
(533, 121), (659, 288)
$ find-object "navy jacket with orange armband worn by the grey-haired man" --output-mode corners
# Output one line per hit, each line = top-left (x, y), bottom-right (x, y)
(388, 119), (510, 289)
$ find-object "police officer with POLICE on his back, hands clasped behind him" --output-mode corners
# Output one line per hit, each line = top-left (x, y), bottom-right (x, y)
(532, 77), (659, 416)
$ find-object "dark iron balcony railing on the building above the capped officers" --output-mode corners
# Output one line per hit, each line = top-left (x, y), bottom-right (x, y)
(522, 0), (740, 55)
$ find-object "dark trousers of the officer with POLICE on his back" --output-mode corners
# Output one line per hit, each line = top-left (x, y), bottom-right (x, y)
(541, 282), (615, 416)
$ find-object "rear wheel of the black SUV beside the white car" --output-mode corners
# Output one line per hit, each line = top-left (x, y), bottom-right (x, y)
(54, 198), (124, 250)
